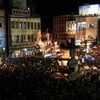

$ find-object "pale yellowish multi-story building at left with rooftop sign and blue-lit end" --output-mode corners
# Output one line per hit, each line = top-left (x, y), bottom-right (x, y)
(0, 0), (41, 55)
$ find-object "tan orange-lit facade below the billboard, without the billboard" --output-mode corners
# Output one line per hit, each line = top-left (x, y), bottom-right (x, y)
(75, 16), (99, 41)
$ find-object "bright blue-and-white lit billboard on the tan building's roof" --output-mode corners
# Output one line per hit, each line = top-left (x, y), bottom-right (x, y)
(79, 4), (100, 15)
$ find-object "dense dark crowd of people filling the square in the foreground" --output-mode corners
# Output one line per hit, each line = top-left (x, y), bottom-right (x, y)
(0, 56), (100, 100)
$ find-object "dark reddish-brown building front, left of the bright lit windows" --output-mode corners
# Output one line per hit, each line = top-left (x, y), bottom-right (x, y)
(53, 15), (75, 44)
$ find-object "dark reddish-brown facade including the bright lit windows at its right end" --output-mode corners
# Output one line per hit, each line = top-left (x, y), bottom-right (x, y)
(53, 14), (76, 44)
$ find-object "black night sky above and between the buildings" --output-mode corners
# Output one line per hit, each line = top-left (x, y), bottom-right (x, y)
(32, 0), (100, 31)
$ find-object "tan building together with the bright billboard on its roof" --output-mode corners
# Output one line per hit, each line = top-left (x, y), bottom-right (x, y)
(75, 4), (100, 42)
